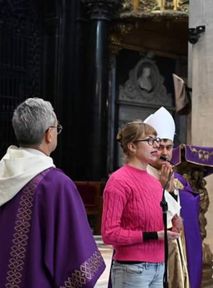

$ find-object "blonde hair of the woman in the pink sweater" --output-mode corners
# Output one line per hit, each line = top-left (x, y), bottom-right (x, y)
(117, 120), (157, 156)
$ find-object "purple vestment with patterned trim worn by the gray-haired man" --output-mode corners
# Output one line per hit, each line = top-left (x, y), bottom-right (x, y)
(0, 168), (105, 288)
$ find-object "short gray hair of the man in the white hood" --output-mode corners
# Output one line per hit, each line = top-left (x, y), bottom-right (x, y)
(12, 98), (57, 145)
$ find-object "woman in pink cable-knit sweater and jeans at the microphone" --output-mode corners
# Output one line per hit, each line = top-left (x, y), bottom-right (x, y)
(102, 121), (179, 288)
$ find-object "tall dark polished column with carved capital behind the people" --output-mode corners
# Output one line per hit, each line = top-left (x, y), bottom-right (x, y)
(82, 0), (119, 180)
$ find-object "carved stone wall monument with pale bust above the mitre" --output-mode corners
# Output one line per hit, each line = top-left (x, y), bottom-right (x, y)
(119, 57), (172, 105)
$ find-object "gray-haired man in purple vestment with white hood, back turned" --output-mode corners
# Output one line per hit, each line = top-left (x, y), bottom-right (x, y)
(0, 98), (105, 288)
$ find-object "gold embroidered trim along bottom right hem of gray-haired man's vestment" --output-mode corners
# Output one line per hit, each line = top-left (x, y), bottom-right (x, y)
(60, 251), (103, 288)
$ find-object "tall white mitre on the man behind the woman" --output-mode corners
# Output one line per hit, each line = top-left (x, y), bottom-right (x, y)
(143, 107), (175, 141)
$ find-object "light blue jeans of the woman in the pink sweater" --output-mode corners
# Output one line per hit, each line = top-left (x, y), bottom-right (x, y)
(111, 261), (165, 288)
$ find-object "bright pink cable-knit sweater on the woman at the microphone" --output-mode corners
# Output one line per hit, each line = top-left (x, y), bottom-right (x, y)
(102, 165), (164, 262)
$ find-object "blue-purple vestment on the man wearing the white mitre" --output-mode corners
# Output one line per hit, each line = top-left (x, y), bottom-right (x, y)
(175, 173), (202, 288)
